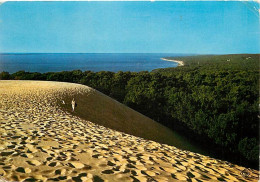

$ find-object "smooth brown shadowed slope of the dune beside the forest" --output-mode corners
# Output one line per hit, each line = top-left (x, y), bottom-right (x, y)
(58, 82), (207, 154)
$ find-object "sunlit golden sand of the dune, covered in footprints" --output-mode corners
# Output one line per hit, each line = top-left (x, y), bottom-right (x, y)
(0, 81), (259, 182)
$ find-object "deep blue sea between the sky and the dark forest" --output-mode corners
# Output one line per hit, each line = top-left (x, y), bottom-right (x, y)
(0, 53), (186, 73)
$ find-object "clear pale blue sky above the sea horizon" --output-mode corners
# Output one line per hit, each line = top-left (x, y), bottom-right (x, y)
(0, 1), (260, 54)
